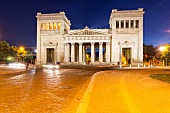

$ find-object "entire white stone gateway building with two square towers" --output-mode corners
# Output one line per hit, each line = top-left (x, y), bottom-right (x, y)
(36, 8), (144, 65)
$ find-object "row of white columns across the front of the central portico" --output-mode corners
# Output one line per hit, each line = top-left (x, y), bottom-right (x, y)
(64, 42), (110, 63)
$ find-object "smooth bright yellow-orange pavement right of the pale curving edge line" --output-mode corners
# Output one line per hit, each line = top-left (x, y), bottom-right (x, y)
(77, 69), (170, 113)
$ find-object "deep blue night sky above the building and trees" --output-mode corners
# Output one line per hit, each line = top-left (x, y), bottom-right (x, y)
(0, 0), (170, 47)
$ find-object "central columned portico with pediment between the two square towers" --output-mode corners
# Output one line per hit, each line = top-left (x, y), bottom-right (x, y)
(63, 26), (111, 64)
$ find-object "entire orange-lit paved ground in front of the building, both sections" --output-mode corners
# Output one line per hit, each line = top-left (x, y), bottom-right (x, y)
(0, 67), (170, 113)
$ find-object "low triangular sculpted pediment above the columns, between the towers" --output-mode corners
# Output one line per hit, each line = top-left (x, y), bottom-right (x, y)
(67, 26), (107, 35)
